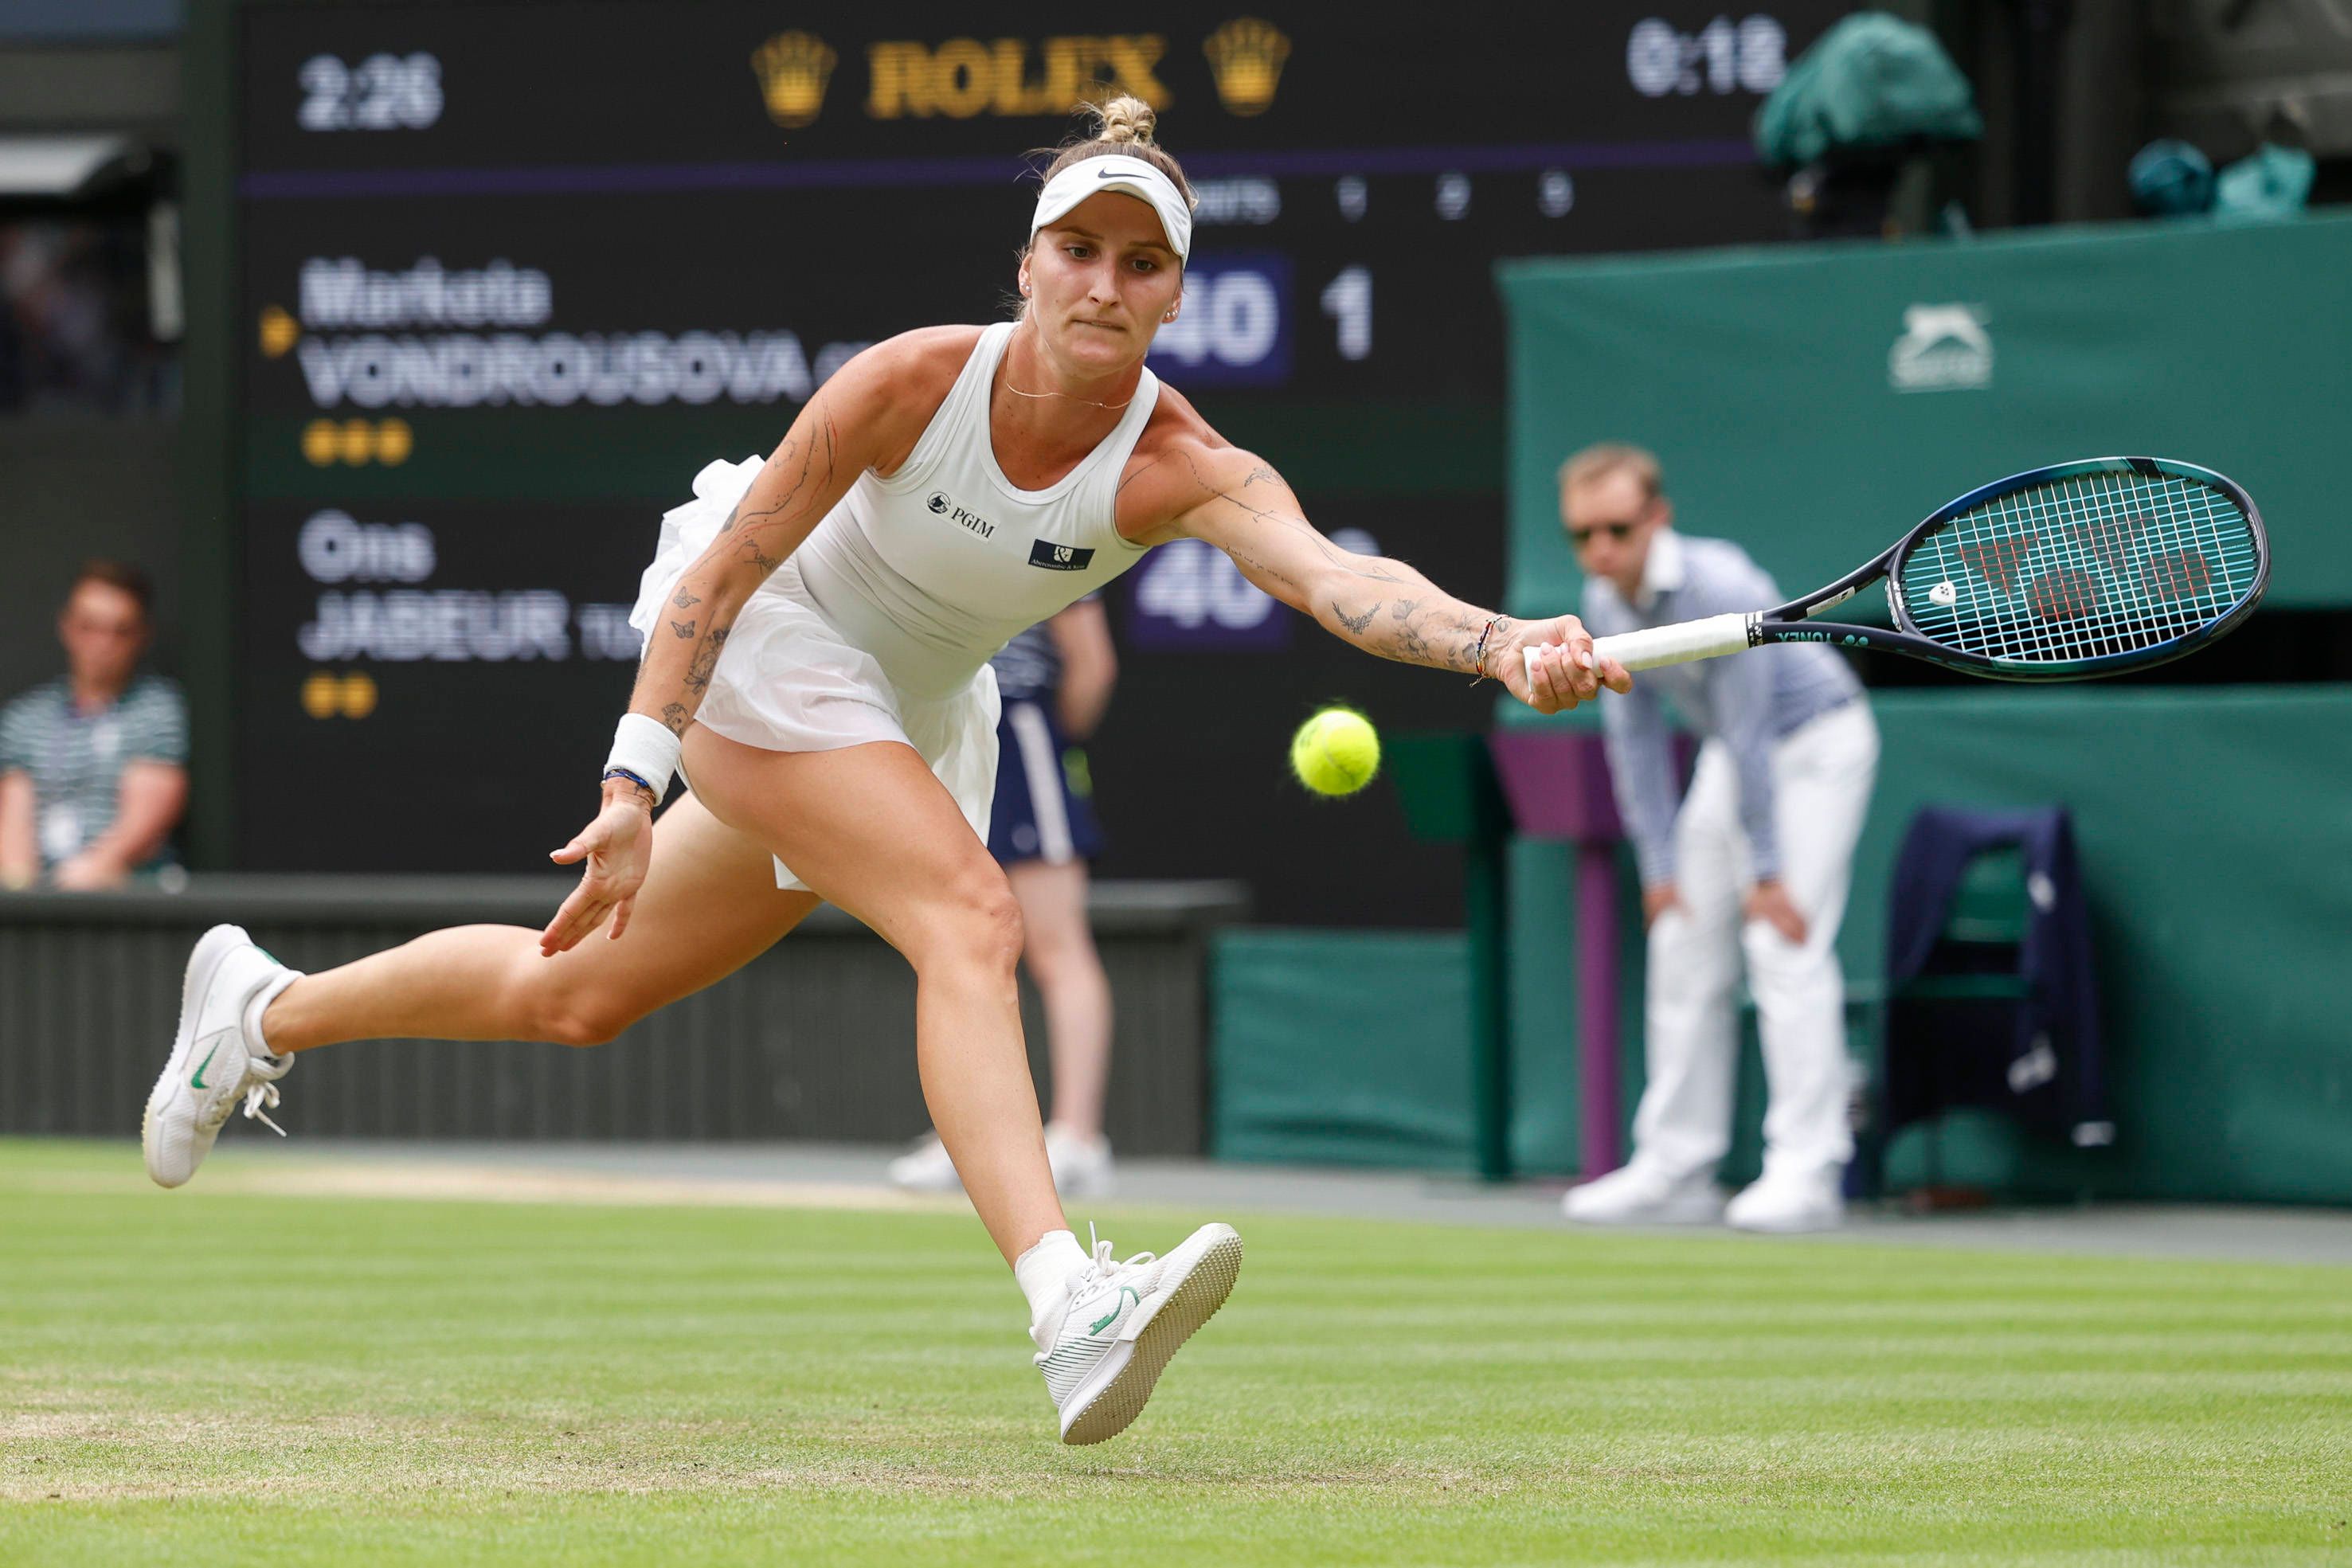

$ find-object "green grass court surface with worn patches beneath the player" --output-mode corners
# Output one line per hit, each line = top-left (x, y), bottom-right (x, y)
(0, 1143), (2352, 1568)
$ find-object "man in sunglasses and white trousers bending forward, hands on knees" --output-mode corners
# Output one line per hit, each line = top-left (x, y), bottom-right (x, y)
(1560, 444), (1879, 1232)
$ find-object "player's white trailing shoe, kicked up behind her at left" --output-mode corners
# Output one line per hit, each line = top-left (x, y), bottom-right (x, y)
(139, 926), (301, 1187)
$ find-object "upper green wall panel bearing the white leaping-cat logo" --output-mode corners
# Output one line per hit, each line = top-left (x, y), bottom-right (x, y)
(1498, 217), (2352, 613)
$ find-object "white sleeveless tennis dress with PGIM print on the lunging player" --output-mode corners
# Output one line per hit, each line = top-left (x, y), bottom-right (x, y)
(628, 322), (1160, 889)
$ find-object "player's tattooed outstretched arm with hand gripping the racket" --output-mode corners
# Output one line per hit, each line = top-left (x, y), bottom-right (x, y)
(1172, 447), (1632, 712)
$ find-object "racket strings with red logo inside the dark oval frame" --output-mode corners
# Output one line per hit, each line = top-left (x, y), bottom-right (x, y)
(1896, 472), (2260, 665)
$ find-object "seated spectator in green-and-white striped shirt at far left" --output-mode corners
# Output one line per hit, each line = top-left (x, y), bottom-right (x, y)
(0, 562), (188, 889)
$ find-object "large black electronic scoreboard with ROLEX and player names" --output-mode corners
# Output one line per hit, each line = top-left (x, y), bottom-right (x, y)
(228, 0), (1846, 921)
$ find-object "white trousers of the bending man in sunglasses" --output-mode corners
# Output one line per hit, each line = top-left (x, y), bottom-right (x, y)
(1632, 698), (1879, 1178)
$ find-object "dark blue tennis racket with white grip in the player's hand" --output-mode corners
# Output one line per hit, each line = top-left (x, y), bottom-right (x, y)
(1526, 459), (2270, 682)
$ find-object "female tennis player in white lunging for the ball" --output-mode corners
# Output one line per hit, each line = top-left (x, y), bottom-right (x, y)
(143, 99), (1630, 1444)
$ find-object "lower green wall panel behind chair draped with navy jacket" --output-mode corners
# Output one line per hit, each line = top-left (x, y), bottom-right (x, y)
(1513, 686), (2352, 1203)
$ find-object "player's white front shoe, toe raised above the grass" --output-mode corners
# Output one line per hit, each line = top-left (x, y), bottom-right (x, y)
(1030, 1225), (1242, 1444)
